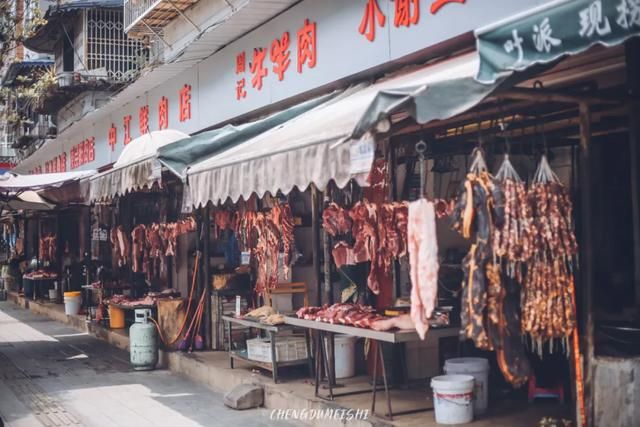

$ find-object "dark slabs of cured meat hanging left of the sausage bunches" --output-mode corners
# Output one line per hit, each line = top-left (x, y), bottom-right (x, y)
(452, 150), (531, 386)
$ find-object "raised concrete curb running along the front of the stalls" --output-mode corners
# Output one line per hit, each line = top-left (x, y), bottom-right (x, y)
(7, 292), (393, 427)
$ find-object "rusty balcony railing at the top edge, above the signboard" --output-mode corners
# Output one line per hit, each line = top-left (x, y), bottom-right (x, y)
(124, 0), (198, 38)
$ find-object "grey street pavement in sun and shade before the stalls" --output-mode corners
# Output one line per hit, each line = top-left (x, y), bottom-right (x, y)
(0, 302), (283, 427)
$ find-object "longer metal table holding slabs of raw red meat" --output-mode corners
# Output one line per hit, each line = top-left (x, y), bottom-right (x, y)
(285, 316), (458, 420)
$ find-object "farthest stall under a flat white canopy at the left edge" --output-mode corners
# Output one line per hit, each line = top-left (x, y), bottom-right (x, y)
(0, 170), (95, 302)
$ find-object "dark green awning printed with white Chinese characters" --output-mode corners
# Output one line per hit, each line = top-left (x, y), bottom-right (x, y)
(475, 0), (640, 83)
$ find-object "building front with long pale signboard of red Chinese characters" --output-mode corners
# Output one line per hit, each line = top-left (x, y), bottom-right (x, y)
(11, 0), (560, 173)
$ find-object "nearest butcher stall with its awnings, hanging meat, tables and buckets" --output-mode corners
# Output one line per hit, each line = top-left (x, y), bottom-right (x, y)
(154, 1), (640, 425)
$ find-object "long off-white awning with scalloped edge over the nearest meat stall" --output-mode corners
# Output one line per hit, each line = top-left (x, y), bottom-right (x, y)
(187, 52), (506, 206)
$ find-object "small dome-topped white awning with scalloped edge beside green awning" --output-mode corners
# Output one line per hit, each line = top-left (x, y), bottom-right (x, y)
(89, 129), (189, 201)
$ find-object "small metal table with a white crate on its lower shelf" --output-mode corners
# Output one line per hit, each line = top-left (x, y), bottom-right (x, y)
(222, 315), (313, 383)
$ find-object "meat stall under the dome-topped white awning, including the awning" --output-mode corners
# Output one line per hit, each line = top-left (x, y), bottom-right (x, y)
(85, 130), (198, 337)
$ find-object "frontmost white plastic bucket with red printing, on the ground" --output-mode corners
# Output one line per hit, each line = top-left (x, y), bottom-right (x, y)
(431, 375), (474, 424)
